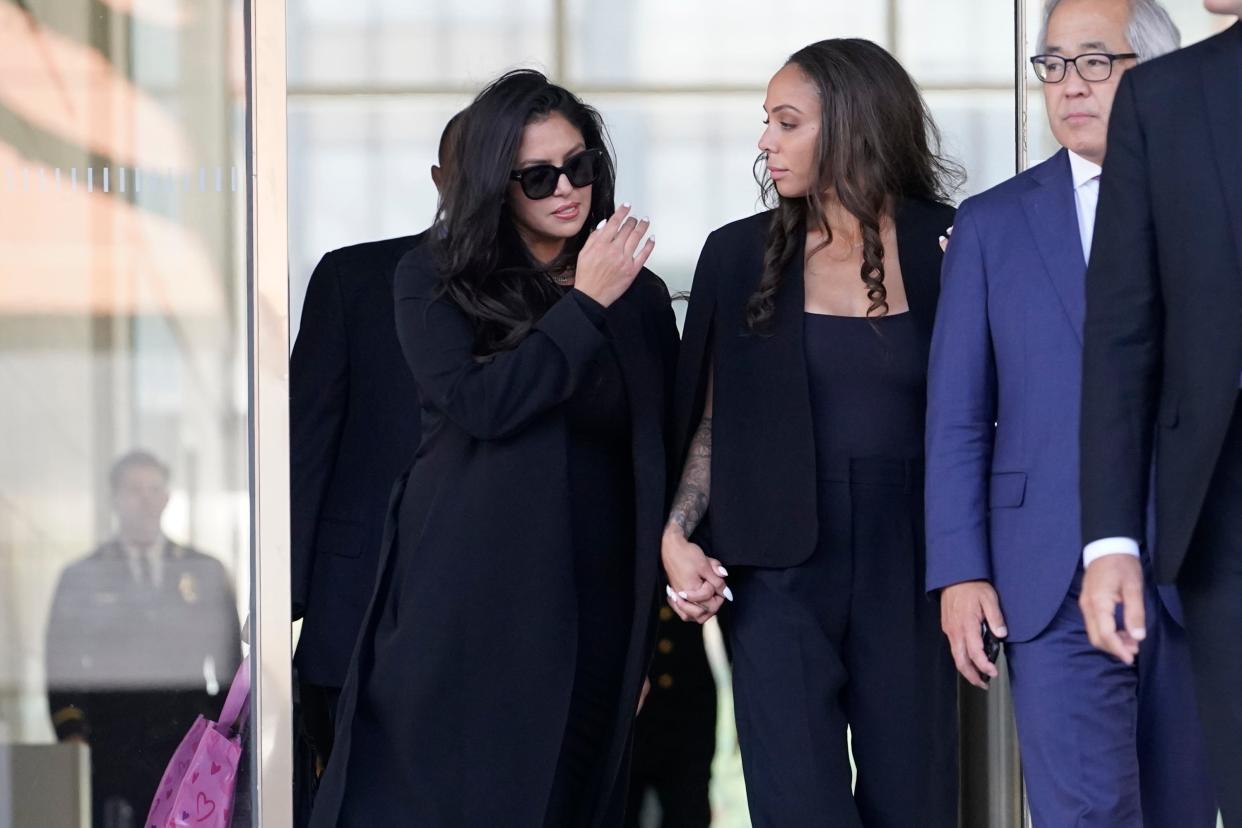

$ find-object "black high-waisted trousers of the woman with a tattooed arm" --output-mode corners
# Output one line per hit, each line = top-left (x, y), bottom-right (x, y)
(728, 459), (958, 828)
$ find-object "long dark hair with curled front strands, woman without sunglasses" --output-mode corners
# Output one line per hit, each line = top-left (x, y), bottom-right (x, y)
(746, 38), (965, 333)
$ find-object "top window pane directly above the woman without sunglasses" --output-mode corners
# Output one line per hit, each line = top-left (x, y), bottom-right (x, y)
(565, 0), (888, 84)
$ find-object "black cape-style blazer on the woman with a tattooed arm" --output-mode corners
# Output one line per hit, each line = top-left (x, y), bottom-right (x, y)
(674, 200), (954, 567)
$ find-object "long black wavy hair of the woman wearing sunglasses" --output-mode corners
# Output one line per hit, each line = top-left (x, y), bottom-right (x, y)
(436, 70), (616, 359)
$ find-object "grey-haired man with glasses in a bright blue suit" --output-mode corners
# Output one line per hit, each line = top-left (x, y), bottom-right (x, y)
(927, 0), (1216, 828)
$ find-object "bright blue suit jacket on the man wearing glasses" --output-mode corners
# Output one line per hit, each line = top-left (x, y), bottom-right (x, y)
(927, 149), (1177, 642)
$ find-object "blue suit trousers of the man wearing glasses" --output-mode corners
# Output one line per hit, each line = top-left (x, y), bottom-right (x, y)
(1005, 570), (1216, 828)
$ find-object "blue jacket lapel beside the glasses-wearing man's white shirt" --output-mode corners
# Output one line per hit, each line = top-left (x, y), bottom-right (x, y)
(1022, 149), (1087, 345)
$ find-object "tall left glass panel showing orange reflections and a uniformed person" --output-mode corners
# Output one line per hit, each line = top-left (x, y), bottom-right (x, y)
(0, 0), (251, 828)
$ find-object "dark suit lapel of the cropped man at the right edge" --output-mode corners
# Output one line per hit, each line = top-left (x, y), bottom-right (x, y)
(1202, 22), (1242, 280)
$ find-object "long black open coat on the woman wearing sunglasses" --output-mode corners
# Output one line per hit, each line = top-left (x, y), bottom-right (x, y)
(312, 252), (677, 828)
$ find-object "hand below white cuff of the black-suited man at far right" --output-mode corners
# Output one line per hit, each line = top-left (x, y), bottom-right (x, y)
(1078, 554), (1148, 664)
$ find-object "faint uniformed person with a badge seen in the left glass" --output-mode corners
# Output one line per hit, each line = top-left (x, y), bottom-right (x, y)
(46, 451), (241, 828)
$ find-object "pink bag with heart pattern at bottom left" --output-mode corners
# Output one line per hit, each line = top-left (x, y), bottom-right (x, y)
(143, 658), (250, 828)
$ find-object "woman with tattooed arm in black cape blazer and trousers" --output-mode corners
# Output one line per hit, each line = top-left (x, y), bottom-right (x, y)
(662, 40), (958, 828)
